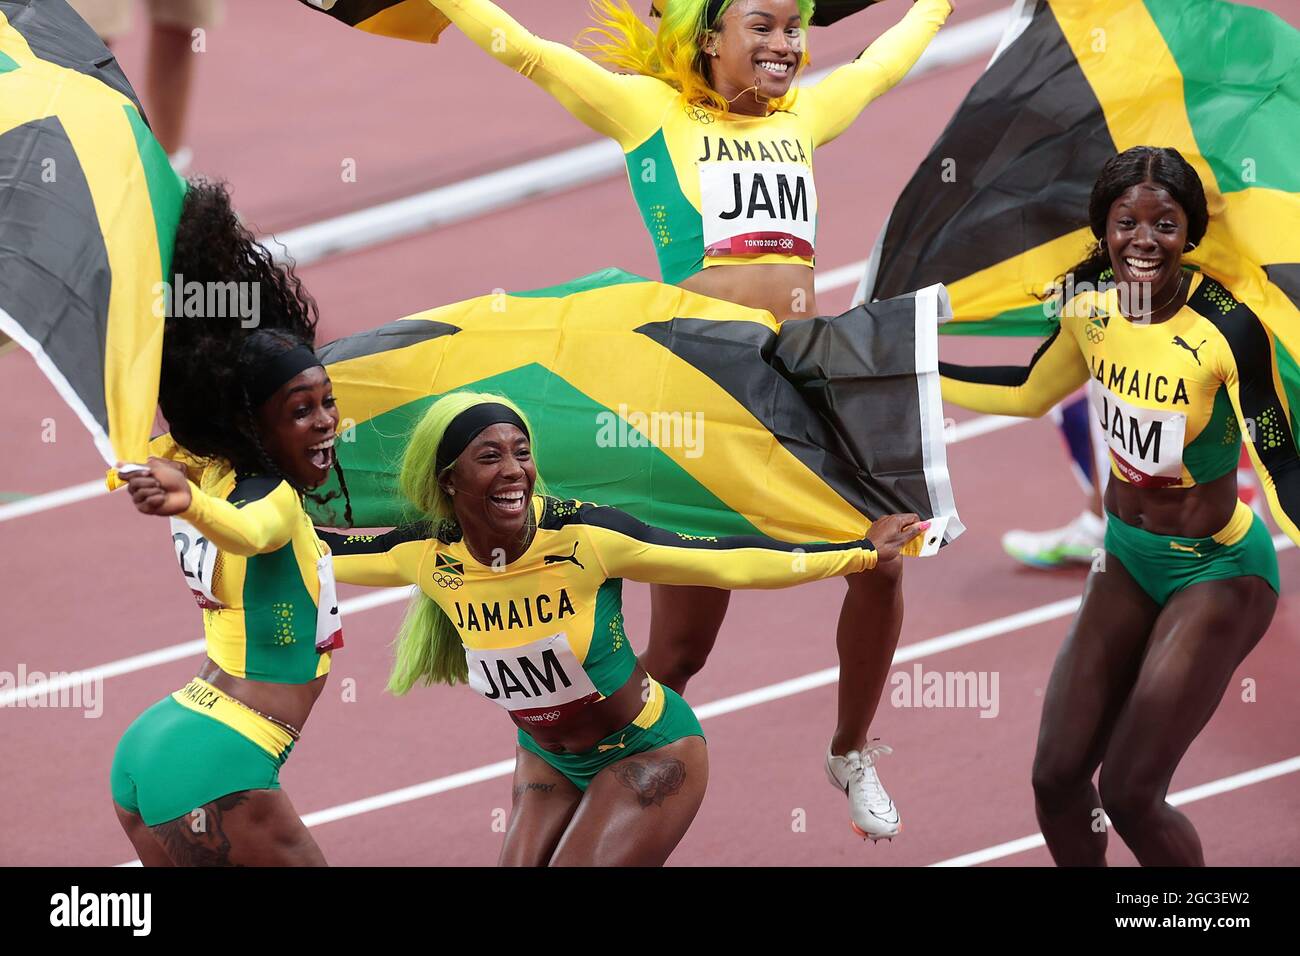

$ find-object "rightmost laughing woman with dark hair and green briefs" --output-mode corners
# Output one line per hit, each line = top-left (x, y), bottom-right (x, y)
(940, 146), (1300, 866)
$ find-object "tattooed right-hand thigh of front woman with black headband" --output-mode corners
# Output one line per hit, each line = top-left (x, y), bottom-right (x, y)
(551, 736), (709, 866)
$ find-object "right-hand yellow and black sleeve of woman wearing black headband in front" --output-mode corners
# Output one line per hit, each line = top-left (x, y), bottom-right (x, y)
(577, 505), (876, 589)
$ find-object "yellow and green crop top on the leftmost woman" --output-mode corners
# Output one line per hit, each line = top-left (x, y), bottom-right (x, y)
(108, 434), (343, 684)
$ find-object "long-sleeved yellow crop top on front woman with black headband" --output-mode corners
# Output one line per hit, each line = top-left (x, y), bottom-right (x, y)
(321, 496), (876, 730)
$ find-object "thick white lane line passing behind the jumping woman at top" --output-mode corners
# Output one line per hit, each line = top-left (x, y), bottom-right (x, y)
(274, 7), (1011, 273)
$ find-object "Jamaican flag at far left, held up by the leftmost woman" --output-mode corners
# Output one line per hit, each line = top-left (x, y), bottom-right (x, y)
(0, 0), (185, 463)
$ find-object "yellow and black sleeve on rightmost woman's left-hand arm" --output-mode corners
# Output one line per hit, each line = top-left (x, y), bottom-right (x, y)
(939, 326), (1088, 419)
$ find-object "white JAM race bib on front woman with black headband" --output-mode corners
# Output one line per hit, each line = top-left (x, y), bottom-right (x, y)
(465, 631), (601, 727)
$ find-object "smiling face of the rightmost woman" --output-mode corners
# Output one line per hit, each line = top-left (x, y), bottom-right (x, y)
(1106, 182), (1187, 308)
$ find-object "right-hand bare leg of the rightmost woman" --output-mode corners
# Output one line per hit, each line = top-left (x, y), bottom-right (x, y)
(1101, 578), (1278, 866)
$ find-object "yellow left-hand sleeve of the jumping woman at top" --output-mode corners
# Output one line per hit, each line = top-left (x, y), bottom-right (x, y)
(429, 0), (676, 152)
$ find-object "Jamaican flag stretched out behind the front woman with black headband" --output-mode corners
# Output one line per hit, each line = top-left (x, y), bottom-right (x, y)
(308, 269), (962, 549)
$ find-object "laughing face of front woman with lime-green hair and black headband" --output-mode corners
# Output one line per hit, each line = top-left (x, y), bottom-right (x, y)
(441, 423), (537, 551)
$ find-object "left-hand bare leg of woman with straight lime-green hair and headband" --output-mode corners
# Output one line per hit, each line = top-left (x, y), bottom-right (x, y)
(497, 747), (582, 866)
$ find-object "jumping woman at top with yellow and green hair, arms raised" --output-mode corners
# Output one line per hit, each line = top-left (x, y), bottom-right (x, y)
(429, 0), (953, 839)
